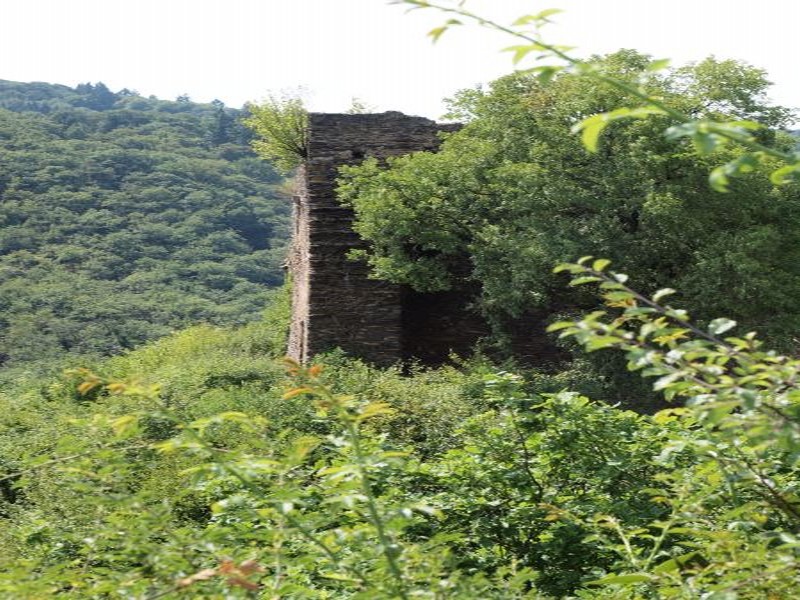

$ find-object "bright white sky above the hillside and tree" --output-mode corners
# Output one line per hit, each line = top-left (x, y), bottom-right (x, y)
(0, 0), (800, 118)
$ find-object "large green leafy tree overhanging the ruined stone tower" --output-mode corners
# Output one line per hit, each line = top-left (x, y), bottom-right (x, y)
(340, 51), (800, 346)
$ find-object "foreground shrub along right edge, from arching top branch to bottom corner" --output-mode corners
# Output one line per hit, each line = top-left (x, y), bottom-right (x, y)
(550, 257), (800, 600)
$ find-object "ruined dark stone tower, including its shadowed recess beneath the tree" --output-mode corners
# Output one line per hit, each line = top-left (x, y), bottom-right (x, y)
(288, 112), (556, 365)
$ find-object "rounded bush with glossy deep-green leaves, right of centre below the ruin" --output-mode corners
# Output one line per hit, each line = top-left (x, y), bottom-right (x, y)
(399, 373), (688, 597)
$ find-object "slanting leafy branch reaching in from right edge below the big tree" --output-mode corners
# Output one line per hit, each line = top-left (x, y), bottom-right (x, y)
(549, 257), (800, 523)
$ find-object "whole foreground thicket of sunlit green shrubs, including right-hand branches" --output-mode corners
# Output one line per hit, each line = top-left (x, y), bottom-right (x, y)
(0, 272), (800, 600)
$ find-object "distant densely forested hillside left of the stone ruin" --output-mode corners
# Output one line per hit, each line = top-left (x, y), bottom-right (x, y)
(0, 81), (289, 372)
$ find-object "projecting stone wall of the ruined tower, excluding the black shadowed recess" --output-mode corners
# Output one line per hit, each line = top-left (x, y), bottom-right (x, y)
(289, 112), (453, 364)
